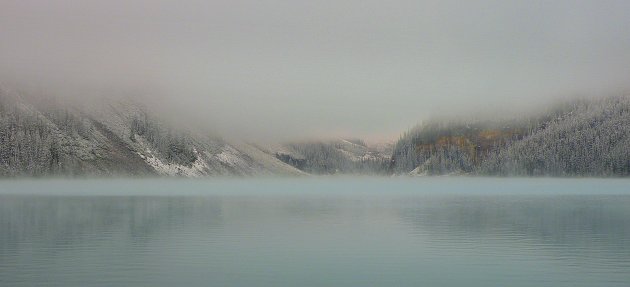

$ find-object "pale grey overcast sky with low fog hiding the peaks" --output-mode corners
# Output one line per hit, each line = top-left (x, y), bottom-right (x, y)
(0, 0), (630, 142)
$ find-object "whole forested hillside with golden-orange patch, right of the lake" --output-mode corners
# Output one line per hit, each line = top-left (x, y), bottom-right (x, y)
(391, 96), (630, 176)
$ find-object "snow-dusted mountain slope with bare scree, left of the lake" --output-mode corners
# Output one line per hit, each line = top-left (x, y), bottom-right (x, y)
(0, 90), (304, 177)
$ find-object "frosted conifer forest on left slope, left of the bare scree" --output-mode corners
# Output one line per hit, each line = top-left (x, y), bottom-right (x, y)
(0, 89), (181, 177)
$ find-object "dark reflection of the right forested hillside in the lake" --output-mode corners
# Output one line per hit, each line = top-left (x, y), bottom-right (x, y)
(400, 195), (630, 254)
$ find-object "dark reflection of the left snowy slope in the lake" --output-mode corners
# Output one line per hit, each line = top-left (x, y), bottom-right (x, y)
(0, 196), (222, 258)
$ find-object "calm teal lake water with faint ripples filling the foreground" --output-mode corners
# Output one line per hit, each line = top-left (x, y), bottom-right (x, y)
(0, 177), (630, 287)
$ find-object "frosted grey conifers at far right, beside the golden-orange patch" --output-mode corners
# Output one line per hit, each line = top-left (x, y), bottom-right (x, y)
(479, 97), (630, 176)
